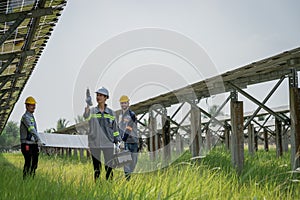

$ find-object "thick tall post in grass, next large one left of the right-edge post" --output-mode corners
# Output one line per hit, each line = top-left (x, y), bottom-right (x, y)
(230, 101), (244, 174)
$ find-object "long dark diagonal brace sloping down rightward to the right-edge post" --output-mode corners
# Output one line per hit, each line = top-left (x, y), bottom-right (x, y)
(228, 82), (290, 124)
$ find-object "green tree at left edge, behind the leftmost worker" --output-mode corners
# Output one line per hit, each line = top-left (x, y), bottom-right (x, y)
(0, 121), (20, 147)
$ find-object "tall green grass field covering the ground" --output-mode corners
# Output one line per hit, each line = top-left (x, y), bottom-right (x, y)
(0, 148), (300, 200)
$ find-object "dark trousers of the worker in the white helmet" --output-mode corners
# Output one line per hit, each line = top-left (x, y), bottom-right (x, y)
(90, 148), (114, 181)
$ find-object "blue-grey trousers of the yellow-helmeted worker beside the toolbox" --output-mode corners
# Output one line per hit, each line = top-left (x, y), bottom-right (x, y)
(124, 143), (138, 180)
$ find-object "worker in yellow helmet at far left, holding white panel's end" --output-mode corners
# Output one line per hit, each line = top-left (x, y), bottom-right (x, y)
(20, 96), (43, 179)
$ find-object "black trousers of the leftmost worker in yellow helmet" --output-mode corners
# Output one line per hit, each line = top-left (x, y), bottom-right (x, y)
(21, 143), (39, 179)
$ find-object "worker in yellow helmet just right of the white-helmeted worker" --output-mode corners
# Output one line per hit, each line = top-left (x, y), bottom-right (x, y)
(118, 95), (139, 180)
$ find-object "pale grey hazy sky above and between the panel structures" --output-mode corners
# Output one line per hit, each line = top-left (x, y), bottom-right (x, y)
(9, 0), (300, 132)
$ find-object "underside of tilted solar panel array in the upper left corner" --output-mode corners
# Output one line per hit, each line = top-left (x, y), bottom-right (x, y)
(0, 0), (66, 134)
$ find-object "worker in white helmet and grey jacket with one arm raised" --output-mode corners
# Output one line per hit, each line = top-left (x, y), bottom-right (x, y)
(83, 87), (120, 182)
